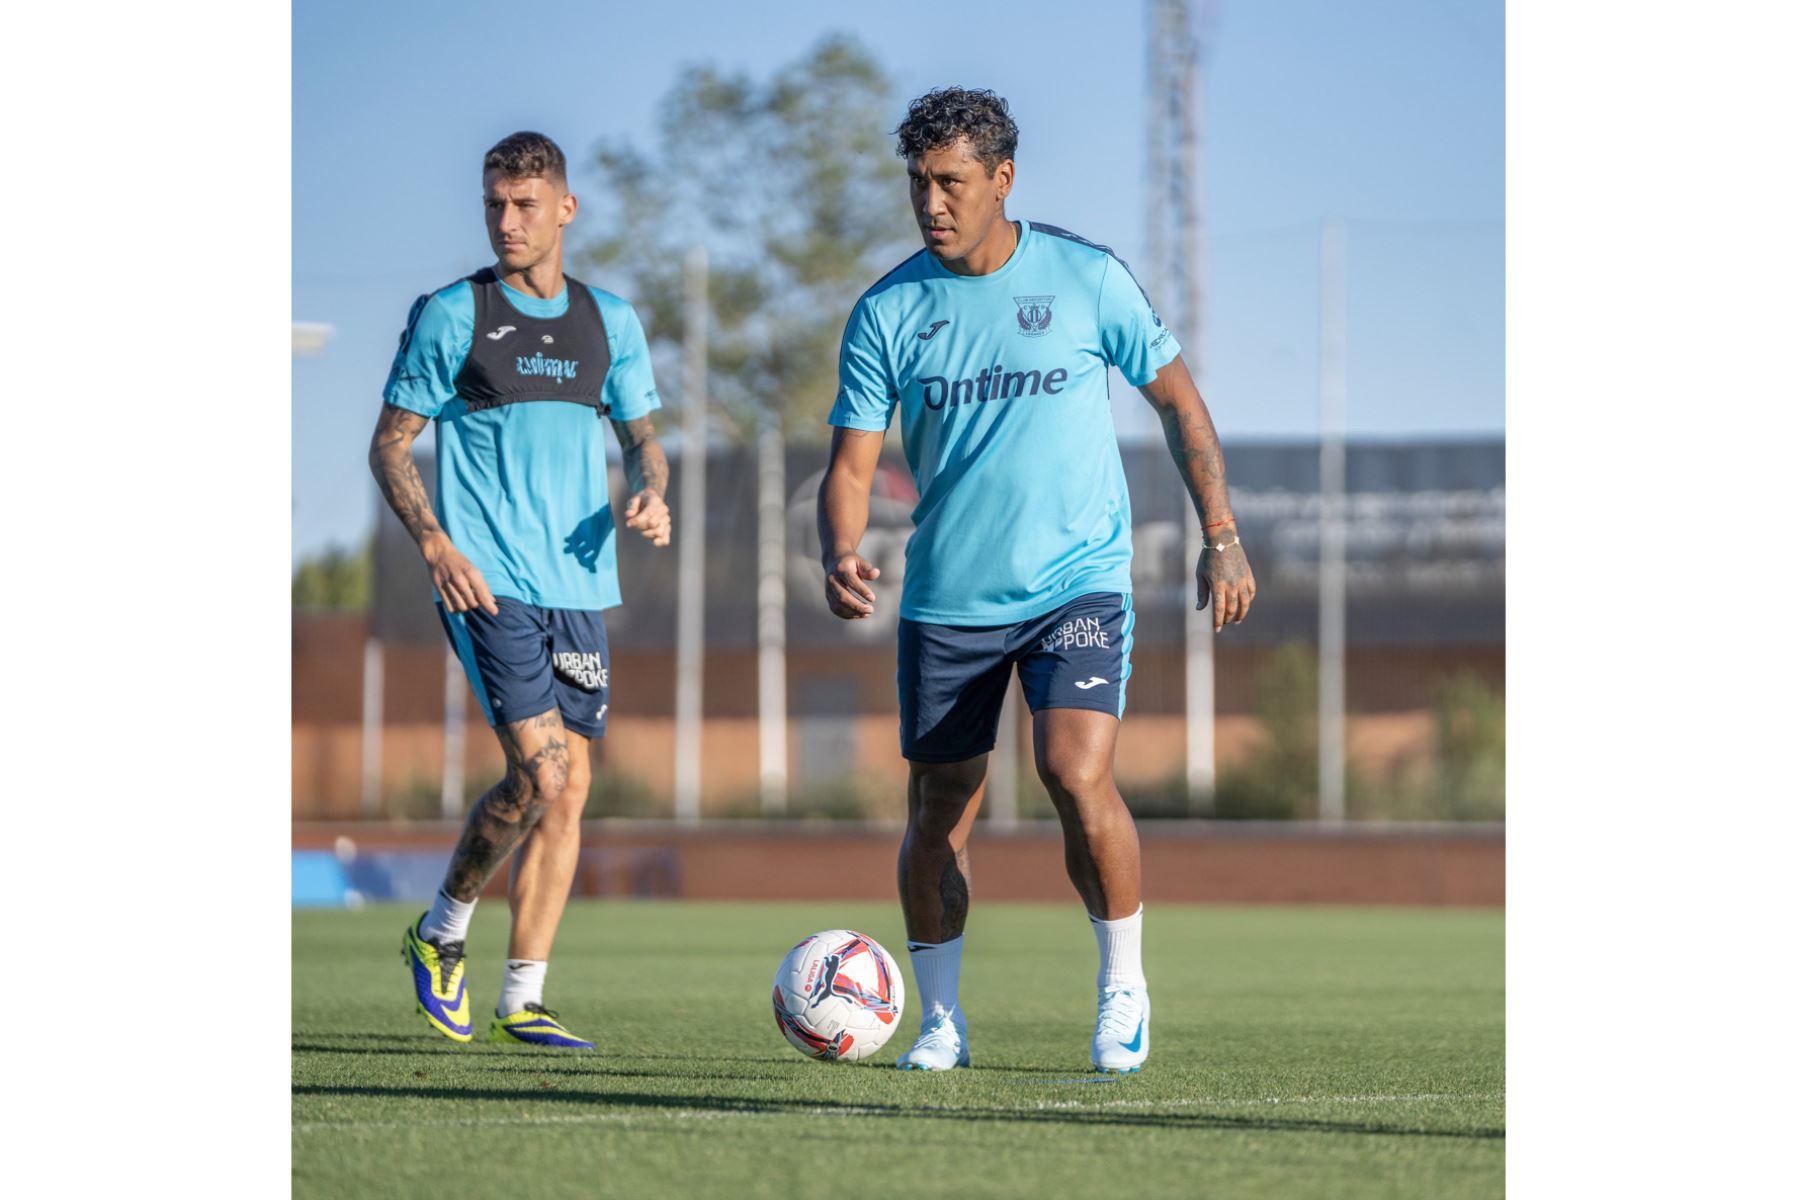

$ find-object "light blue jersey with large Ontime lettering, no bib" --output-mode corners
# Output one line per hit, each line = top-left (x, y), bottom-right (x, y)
(830, 221), (1181, 626)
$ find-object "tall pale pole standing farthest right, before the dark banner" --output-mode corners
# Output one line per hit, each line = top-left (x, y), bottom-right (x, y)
(1319, 221), (1346, 822)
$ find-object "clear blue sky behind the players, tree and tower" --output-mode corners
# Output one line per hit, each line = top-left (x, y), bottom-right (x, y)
(293, 0), (1505, 558)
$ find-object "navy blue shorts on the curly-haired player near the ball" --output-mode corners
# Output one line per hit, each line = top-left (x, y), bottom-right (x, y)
(900, 592), (1134, 763)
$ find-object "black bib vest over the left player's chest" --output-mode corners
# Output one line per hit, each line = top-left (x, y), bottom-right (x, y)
(455, 266), (612, 417)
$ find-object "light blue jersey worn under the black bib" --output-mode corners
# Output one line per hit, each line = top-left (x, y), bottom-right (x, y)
(382, 279), (662, 612)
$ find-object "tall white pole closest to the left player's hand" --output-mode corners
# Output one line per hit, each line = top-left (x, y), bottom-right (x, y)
(675, 246), (707, 824)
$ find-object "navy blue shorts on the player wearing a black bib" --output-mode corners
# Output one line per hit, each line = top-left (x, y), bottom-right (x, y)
(437, 596), (610, 738)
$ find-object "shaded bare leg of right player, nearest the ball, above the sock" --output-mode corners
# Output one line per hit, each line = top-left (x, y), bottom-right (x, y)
(900, 754), (988, 943)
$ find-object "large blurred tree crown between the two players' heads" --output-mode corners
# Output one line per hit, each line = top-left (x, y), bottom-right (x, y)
(578, 34), (918, 439)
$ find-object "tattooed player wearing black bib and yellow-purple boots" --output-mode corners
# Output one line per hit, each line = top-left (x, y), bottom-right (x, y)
(369, 133), (670, 1049)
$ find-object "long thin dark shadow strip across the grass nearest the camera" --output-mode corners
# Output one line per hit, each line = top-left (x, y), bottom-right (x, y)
(293, 1083), (1507, 1141)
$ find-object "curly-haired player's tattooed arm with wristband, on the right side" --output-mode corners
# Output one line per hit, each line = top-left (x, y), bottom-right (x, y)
(1139, 354), (1256, 633)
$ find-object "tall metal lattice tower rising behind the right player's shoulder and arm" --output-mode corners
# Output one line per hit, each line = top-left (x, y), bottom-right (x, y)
(1145, 0), (1217, 813)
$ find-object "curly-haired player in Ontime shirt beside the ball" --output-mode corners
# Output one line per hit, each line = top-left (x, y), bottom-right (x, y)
(819, 88), (1256, 1070)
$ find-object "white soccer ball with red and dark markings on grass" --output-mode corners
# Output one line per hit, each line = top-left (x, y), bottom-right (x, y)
(774, 928), (905, 1063)
